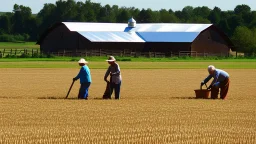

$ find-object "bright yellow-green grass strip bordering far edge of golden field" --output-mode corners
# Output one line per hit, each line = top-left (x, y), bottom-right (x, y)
(0, 61), (256, 69)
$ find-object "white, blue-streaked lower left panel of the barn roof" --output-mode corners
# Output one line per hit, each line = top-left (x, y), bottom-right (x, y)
(78, 31), (145, 42)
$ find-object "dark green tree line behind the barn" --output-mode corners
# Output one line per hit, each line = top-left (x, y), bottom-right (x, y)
(0, 0), (256, 52)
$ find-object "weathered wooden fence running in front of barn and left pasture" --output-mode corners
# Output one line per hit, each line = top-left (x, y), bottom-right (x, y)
(0, 49), (230, 57)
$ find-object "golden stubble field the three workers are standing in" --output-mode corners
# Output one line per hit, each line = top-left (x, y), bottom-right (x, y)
(0, 67), (256, 144)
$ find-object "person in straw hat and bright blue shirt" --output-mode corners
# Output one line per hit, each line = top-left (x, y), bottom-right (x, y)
(73, 58), (92, 99)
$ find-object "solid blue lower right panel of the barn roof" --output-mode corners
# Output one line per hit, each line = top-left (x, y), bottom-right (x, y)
(136, 32), (199, 42)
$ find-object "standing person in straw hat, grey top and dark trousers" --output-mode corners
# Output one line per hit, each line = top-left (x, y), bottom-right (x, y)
(104, 56), (122, 99)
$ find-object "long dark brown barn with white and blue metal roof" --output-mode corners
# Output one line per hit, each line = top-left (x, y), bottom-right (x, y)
(37, 18), (235, 56)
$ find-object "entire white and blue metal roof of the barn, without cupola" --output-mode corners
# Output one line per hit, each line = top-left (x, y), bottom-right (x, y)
(63, 22), (212, 42)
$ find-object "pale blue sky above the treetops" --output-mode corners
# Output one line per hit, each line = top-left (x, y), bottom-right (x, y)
(0, 0), (256, 14)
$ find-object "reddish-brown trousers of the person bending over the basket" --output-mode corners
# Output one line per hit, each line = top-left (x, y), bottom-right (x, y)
(211, 78), (230, 99)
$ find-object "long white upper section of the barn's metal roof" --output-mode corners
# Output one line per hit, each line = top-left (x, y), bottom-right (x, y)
(62, 22), (212, 32)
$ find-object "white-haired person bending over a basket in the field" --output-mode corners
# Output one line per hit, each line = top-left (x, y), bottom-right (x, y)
(201, 65), (230, 99)
